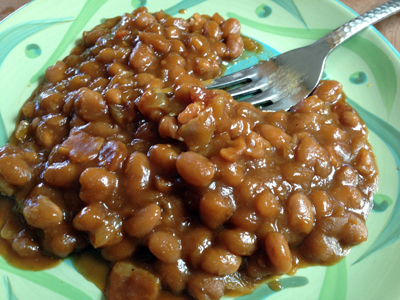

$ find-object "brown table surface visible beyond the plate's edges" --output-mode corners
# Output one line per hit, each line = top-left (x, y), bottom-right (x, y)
(0, 0), (400, 52)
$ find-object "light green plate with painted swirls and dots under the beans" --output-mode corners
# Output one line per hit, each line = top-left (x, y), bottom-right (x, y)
(0, 0), (400, 300)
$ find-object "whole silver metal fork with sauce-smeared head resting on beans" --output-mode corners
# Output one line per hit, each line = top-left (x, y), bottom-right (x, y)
(207, 0), (400, 111)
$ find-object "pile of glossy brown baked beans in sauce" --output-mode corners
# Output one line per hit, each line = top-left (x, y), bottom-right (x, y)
(0, 7), (378, 300)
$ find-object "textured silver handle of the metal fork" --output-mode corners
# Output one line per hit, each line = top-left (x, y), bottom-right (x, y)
(321, 0), (400, 52)
